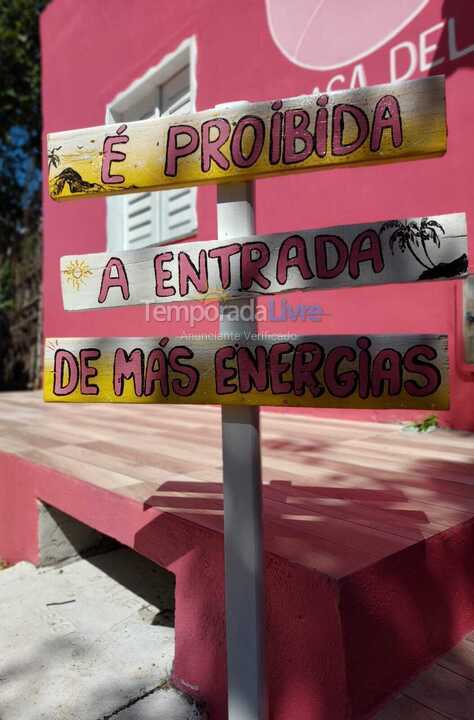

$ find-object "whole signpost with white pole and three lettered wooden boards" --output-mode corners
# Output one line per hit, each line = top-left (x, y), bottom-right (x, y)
(44, 77), (460, 720)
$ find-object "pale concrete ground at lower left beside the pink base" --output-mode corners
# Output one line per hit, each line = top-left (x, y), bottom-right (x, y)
(0, 548), (201, 720)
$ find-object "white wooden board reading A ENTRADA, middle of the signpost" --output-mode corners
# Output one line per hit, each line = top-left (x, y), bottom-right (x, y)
(61, 213), (468, 310)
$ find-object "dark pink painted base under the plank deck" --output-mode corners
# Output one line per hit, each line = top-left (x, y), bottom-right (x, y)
(0, 453), (474, 720)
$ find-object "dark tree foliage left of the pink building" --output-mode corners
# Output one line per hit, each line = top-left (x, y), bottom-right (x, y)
(0, 0), (48, 390)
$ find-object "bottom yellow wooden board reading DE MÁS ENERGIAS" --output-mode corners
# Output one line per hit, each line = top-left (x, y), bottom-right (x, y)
(44, 335), (449, 410)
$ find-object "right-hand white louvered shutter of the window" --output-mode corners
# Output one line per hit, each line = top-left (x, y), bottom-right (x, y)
(160, 67), (197, 242)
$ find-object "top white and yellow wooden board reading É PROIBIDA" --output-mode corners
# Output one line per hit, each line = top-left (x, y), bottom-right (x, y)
(48, 77), (446, 200)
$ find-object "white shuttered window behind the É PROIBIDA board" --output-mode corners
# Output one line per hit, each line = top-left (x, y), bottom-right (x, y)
(106, 38), (197, 250)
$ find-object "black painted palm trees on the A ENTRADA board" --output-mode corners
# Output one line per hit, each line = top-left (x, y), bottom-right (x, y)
(380, 217), (445, 270)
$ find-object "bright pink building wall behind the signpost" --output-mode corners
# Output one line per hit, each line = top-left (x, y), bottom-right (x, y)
(41, 0), (474, 429)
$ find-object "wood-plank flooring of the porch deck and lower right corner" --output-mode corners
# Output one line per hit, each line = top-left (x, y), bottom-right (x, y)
(0, 393), (474, 720)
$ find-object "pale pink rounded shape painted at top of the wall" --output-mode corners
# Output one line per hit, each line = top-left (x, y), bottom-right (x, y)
(266, 0), (429, 70)
